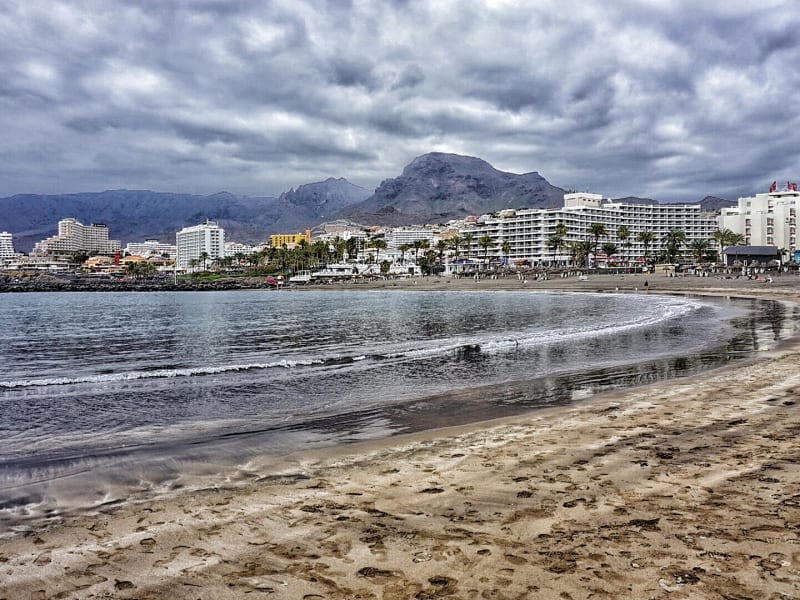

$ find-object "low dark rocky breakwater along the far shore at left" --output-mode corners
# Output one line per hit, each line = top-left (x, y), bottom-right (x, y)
(0, 271), (272, 292)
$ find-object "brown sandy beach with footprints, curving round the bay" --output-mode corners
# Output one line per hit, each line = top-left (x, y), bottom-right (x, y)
(0, 275), (800, 600)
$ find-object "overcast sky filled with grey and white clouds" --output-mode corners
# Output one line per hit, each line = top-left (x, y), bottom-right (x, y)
(0, 0), (800, 201)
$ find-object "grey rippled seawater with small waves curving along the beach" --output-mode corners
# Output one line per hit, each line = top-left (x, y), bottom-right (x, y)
(0, 290), (796, 532)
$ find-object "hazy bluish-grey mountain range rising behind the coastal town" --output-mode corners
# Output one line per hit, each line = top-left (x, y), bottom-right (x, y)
(0, 152), (733, 252)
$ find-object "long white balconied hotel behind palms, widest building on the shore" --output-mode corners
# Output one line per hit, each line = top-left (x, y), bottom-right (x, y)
(460, 193), (717, 264)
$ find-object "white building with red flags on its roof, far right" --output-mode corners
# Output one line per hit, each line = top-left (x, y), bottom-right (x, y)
(719, 183), (800, 253)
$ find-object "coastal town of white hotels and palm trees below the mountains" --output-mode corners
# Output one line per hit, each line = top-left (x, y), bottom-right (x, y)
(0, 181), (800, 287)
